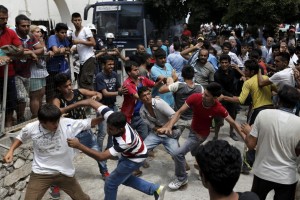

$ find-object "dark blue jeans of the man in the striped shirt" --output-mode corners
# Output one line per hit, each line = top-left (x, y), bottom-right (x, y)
(104, 156), (159, 200)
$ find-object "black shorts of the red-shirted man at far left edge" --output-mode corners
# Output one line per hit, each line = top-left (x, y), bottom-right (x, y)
(0, 77), (17, 112)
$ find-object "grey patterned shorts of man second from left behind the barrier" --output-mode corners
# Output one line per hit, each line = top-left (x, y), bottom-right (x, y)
(15, 76), (30, 102)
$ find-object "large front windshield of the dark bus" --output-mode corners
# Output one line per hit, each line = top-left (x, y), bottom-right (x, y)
(95, 4), (143, 38)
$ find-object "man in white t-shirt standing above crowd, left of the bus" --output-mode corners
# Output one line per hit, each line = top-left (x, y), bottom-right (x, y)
(72, 13), (96, 90)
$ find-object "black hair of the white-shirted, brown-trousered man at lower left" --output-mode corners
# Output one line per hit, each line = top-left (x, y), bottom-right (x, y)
(38, 103), (61, 123)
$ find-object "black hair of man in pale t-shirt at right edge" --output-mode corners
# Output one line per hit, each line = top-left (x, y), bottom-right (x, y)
(278, 85), (300, 108)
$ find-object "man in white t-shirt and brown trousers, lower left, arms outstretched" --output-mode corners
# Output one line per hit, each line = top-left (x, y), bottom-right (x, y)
(3, 103), (102, 200)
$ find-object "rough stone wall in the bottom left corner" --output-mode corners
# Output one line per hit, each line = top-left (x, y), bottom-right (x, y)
(0, 143), (33, 200)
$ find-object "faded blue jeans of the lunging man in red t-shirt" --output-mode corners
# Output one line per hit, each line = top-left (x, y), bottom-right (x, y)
(173, 131), (206, 181)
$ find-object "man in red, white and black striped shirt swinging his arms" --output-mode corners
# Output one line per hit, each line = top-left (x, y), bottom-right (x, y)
(68, 99), (166, 200)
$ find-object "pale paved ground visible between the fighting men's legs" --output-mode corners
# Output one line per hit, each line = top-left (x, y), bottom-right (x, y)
(35, 107), (286, 200)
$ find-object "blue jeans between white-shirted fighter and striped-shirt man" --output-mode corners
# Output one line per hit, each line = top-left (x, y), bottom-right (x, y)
(76, 129), (108, 174)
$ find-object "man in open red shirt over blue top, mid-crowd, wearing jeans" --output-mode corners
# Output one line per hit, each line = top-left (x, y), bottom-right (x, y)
(121, 61), (161, 140)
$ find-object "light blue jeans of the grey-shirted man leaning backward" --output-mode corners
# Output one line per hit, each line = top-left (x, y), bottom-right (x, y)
(144, 132), (180, 176)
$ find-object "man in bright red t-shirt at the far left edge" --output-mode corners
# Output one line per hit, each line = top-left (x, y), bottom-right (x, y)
(0, 5), (23, 127)
